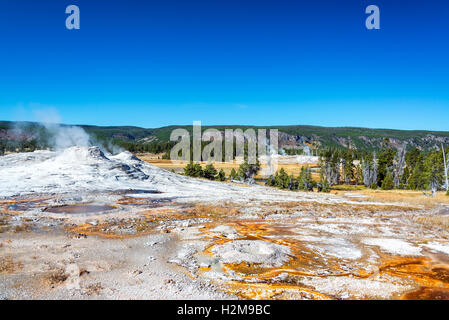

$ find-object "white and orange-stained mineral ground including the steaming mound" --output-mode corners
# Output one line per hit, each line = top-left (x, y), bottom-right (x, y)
(0, 148), (449, 299)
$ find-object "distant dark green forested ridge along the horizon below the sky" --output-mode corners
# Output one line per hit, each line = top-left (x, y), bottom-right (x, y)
(0, 121), (449, 154)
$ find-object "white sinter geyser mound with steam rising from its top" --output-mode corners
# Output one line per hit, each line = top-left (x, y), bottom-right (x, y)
(0, 147), (149, 197)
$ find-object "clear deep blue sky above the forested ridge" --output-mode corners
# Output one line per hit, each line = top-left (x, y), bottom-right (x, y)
(0, 0), (449, 131)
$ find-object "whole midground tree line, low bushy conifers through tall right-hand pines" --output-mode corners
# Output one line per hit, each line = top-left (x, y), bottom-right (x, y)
(184, 139), (449, 195)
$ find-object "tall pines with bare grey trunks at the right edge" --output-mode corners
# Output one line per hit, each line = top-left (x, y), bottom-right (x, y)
(320, 139), (449, 192)
